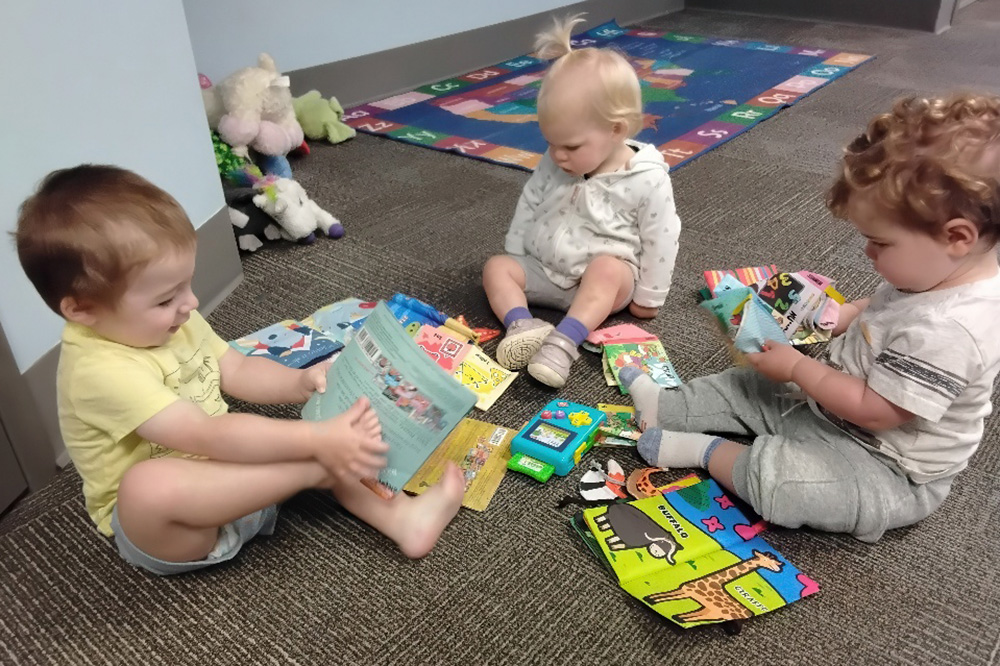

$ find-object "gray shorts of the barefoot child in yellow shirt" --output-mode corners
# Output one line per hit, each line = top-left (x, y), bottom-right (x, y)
(111, 504), (278, 576)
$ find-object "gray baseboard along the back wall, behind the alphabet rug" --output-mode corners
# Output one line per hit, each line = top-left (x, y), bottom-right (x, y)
(288, 0), (684, 107)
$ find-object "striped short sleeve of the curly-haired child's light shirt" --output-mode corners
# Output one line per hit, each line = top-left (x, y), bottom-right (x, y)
(868, 321), (984, 422)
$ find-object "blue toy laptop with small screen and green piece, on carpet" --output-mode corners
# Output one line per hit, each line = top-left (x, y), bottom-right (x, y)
(507, 400), (607, 481)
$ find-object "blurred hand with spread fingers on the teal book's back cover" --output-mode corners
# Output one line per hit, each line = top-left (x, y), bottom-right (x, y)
(312, 398), (389, 482)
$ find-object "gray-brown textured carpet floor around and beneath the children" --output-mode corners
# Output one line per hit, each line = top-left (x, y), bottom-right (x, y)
(0, 5), (1000, 666)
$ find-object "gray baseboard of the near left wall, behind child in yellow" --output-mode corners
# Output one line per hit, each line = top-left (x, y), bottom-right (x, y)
(12, 206), (243, 492)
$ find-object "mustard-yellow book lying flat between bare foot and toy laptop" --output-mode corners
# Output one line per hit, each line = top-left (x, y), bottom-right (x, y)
(403, 418), (514, 511)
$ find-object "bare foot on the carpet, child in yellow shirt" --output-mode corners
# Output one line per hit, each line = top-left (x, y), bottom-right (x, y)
(388, 463), (465, 559)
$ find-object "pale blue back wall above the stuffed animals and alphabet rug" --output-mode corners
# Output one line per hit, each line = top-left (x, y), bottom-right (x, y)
(184, 0), (573, 81)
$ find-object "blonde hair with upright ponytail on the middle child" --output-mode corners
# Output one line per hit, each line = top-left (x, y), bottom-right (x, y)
(535, 14), (642, 137)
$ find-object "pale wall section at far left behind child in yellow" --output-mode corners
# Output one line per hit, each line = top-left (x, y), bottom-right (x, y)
(0, 0), (224, 372)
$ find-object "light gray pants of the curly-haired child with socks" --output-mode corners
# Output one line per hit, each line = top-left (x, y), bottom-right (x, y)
(657, 368), (954, 542)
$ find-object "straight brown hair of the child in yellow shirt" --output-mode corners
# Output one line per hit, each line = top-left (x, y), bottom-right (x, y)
(14, 164), (197, 316)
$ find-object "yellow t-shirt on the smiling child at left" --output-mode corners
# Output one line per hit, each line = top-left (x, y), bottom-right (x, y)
(56, 311), (229, 536)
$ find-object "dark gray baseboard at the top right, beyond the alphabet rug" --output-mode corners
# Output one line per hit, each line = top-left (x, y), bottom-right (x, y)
(685, 0), (956, 32)
